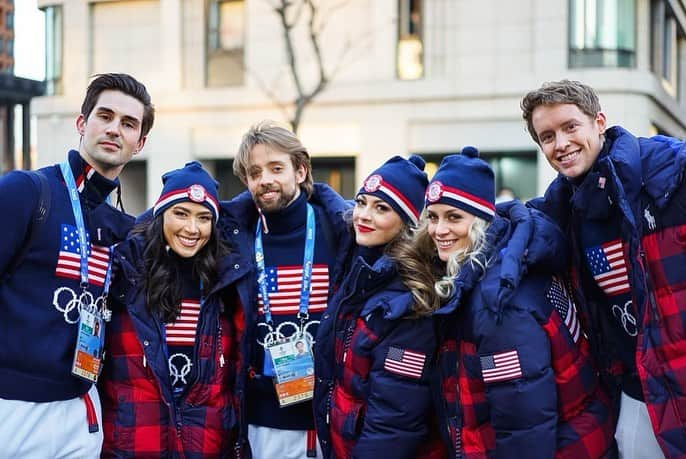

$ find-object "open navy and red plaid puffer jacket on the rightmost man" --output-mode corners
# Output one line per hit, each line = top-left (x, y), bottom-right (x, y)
(532, 126), (686, 458)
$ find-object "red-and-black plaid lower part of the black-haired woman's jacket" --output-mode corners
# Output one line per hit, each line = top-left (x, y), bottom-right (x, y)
(100, 296), (243, 459)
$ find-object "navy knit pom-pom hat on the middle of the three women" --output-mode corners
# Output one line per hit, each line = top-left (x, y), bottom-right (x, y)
(357, 155), (429, 226)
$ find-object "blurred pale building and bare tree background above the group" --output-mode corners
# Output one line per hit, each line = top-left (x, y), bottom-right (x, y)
(0, 0), (686, 213)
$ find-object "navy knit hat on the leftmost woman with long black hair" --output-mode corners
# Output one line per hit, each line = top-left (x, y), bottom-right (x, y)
(152, 161), (219, 221)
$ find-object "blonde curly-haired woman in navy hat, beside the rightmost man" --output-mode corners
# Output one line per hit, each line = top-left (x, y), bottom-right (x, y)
(400, 147), (614, 459)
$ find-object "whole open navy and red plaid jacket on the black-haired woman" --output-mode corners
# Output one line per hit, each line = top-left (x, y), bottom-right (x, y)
(99, 235), (250, 459)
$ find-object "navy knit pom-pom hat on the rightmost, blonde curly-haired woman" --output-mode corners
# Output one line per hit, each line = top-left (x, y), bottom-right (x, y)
(426, 147), (495, 222)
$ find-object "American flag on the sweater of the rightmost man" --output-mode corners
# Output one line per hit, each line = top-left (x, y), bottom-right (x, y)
(586, 239), (629, 296)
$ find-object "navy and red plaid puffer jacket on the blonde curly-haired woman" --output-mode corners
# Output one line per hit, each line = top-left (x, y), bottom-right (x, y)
(436, 217), (614, 459)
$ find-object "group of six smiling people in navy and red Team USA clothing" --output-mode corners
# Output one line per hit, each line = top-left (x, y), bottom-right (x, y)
(0, 74), (686, 459)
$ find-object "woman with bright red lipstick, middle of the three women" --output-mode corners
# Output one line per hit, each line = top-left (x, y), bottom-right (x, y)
(314, 156), (445, 459)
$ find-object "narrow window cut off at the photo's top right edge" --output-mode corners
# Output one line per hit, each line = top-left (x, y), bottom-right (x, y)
(651, 0), (686, 99)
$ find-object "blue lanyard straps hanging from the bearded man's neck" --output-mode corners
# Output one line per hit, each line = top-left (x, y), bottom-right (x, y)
(255, 203), (315, 323)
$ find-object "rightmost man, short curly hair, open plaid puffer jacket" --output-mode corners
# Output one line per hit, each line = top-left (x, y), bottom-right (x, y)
(521, 80), (686, 458)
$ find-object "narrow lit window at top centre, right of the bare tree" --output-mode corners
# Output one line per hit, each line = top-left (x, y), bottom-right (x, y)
(396, 0), (424, 80)
